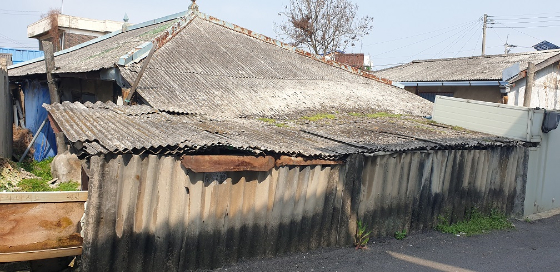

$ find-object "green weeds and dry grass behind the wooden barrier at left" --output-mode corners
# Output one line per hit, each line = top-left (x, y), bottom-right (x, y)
(0, 158), (79, 192)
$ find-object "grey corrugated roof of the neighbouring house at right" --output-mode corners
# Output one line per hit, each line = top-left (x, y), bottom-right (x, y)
(374, 50), (560, 82)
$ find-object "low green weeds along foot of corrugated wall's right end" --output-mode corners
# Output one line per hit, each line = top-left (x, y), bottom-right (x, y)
(436, 209), (514, 236)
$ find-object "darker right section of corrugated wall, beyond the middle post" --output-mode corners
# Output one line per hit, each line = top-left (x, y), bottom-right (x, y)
(358, 148), (528, 237)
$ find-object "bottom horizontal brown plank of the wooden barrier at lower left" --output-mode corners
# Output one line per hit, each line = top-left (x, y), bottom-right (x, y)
(0, 246), (82, 263)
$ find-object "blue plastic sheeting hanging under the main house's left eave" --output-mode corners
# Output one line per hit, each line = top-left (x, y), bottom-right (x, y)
(23, 81), (56, 161)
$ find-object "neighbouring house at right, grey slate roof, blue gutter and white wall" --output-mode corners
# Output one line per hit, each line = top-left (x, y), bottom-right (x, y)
(374, 50), (560, 105)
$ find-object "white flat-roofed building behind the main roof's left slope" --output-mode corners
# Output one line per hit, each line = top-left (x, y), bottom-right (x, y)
(27, 13), (123, 51)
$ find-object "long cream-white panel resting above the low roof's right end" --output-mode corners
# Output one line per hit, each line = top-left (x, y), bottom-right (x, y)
(432, 96), (544, 142)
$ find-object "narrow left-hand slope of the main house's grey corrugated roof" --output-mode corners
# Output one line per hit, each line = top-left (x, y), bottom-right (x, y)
(8, 19), (177, 77)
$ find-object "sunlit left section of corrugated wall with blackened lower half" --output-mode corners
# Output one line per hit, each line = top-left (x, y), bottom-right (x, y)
(83, 155), (341, 271)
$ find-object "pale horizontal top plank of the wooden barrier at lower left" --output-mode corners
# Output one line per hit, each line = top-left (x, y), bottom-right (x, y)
(0, 191), (87, 204)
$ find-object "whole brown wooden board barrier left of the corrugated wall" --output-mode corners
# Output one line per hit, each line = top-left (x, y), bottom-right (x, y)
(0, 192), (87, 262)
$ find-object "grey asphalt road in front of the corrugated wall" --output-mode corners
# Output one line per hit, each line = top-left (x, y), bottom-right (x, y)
(218, 215), (560, 272)
